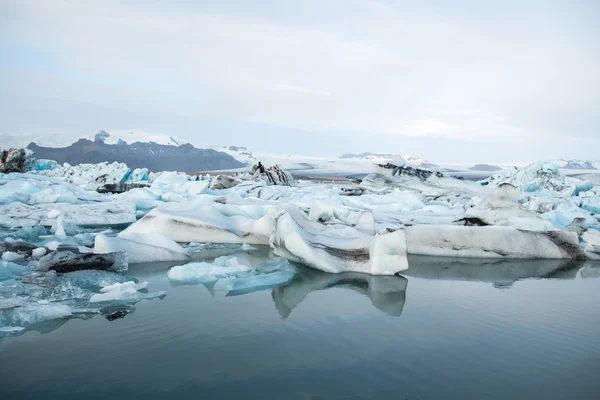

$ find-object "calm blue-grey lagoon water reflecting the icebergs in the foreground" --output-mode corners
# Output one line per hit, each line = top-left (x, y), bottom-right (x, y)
(0, 252), (600, 399)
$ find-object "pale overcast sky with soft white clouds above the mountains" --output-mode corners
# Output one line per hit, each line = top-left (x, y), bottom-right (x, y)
(0, 0), (600, 162)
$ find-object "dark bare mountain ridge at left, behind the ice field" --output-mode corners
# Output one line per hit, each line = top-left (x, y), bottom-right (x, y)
(27, 138), (245, 172)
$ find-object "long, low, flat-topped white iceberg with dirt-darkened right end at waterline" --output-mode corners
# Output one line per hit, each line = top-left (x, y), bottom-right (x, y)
(404, 225), (584, 259)
